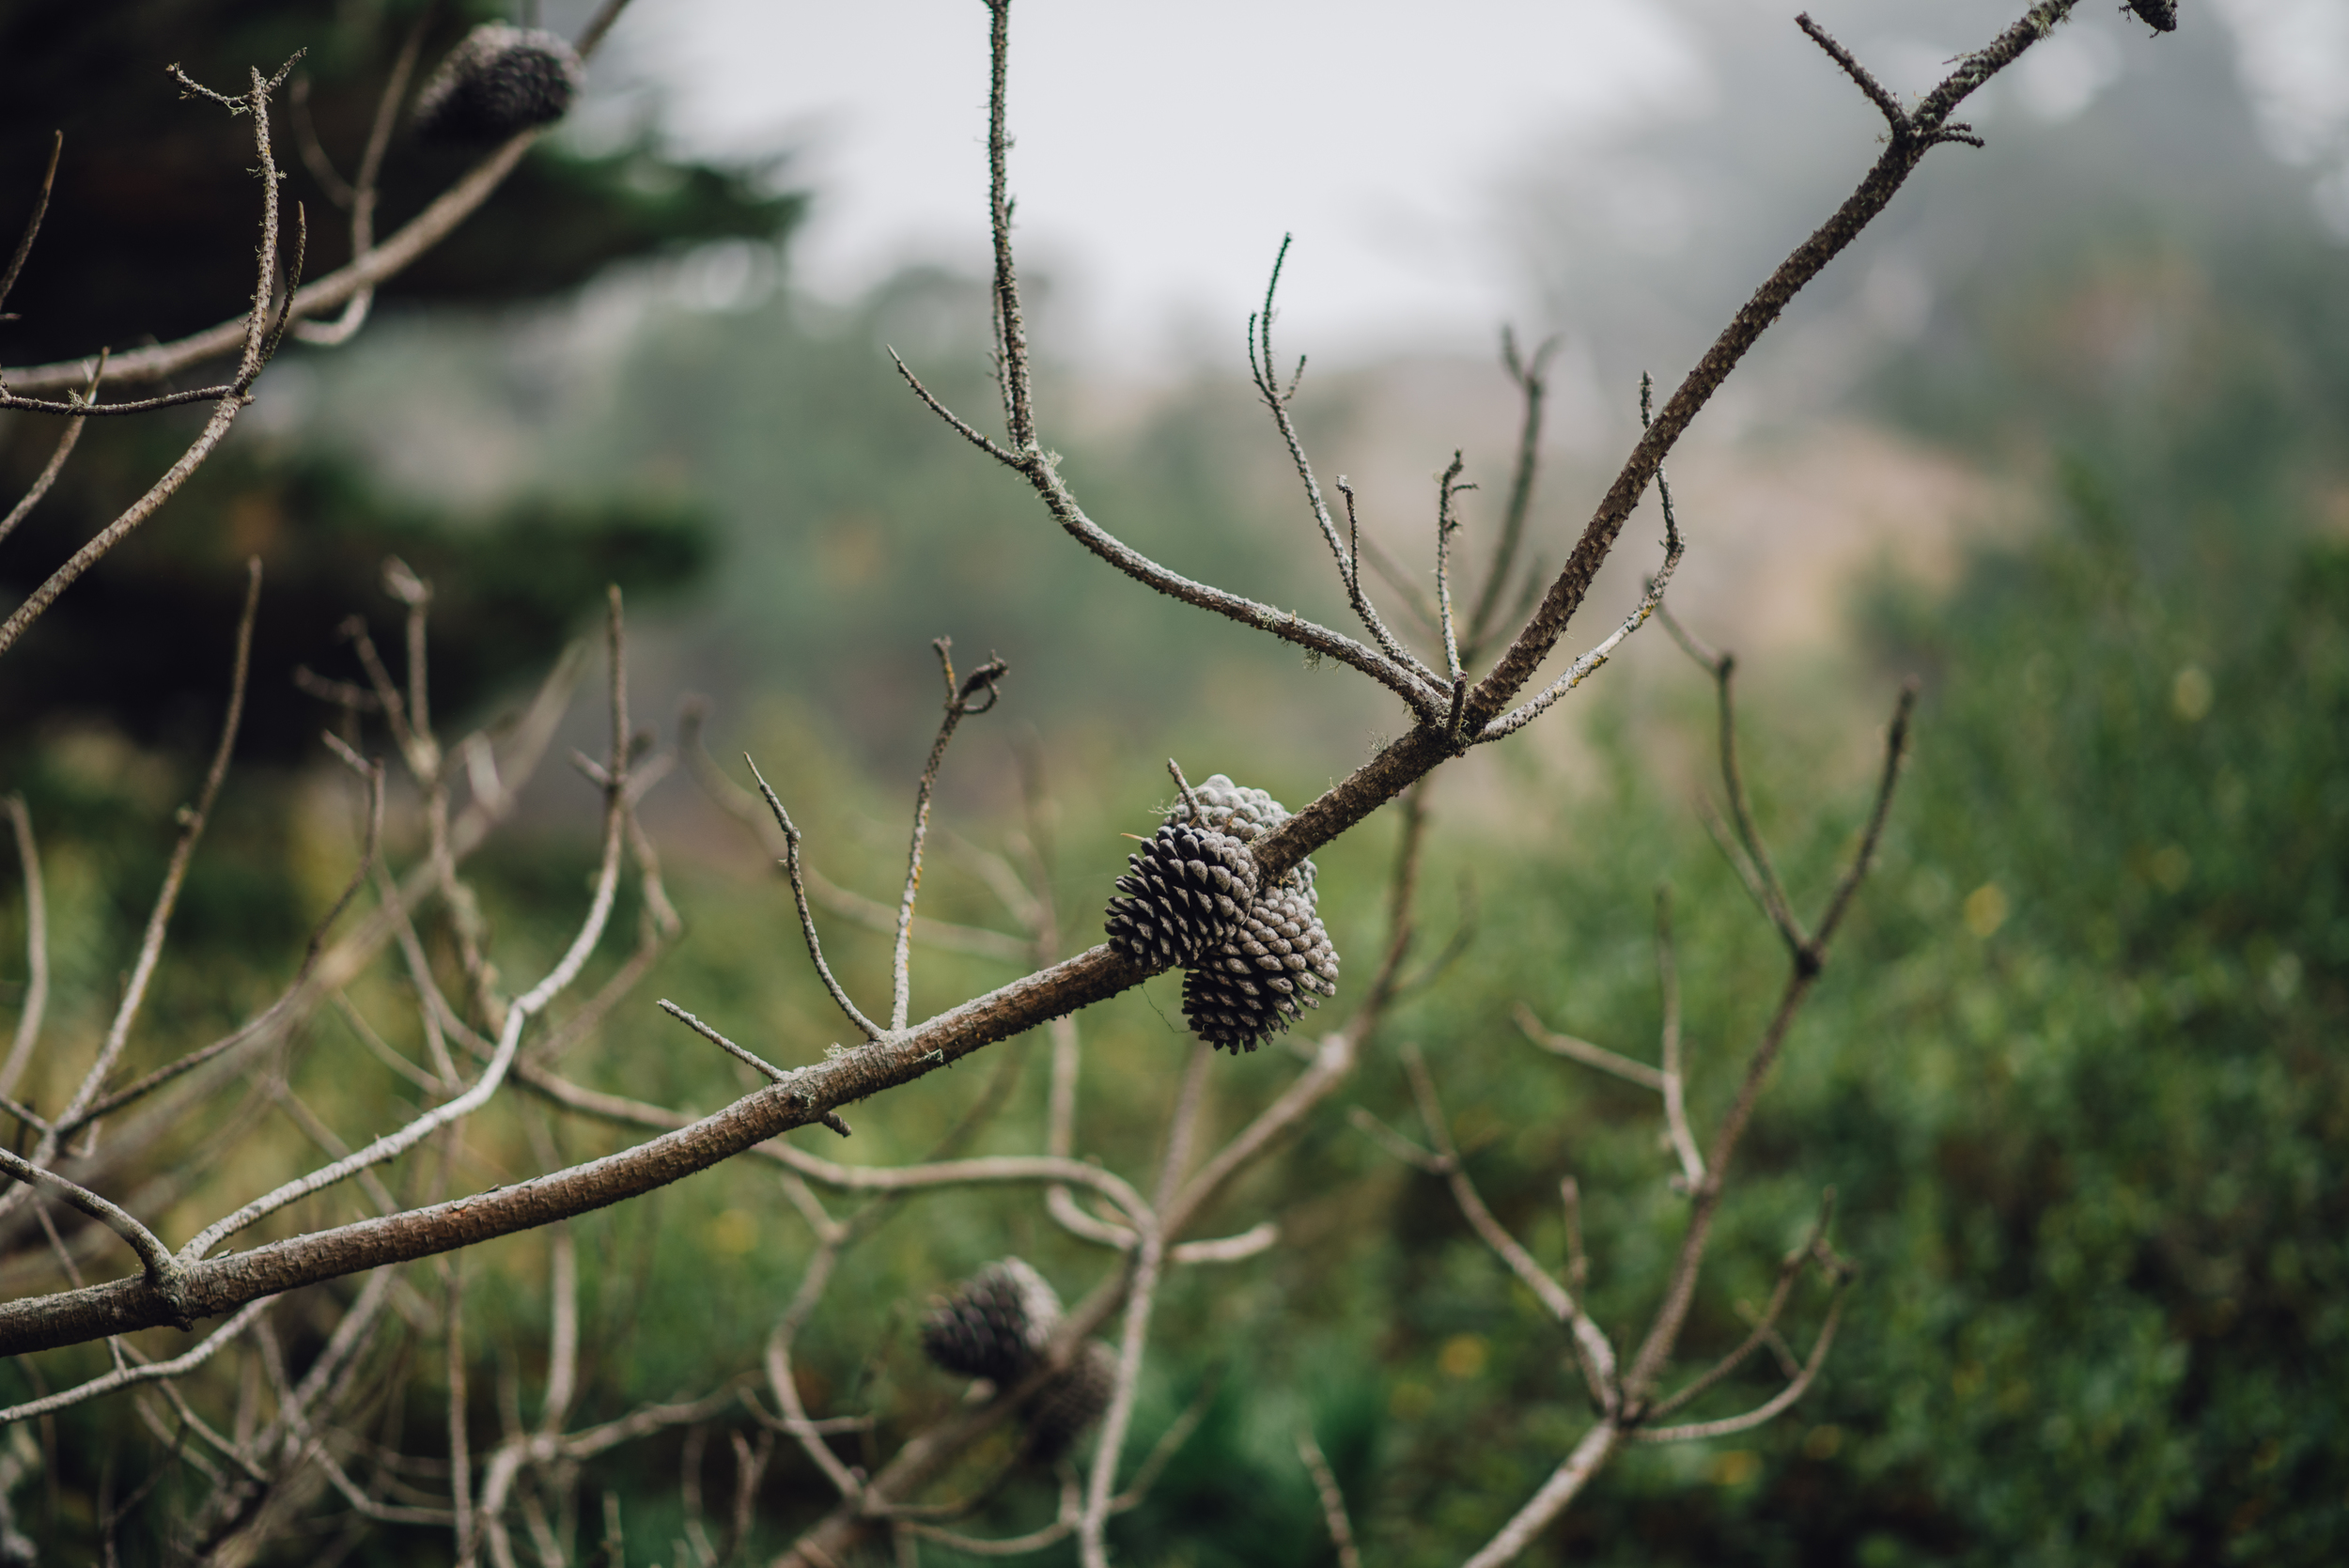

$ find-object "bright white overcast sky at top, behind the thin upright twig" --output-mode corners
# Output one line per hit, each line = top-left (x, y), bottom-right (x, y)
(597, 0), (1703, 362)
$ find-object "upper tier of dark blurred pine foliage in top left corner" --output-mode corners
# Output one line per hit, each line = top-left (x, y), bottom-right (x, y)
(0, 0), (806, 364)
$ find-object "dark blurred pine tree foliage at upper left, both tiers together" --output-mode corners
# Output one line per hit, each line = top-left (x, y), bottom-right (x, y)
(0, 0), (803, 758)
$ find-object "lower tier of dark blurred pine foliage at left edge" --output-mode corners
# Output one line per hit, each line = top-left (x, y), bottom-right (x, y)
(0, 434), (714, 763)
